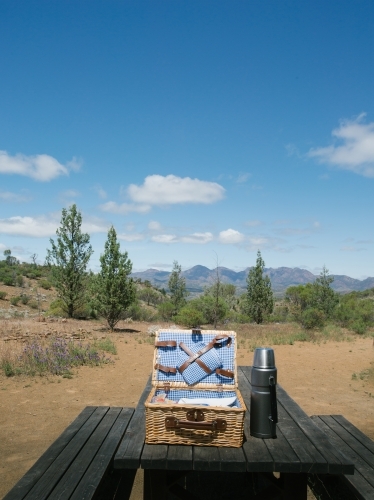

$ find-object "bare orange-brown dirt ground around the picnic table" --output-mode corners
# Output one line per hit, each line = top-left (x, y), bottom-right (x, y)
(0, 320), (374, 500)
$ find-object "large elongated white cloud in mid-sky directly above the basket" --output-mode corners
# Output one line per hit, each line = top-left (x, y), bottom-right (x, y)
(127, 175), (225, 205)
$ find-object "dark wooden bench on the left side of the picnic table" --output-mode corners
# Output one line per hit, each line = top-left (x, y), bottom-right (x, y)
(4, 406), (136, 500)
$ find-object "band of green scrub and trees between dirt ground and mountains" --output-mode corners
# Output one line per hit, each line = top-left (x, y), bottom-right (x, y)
(0, 205), (374, 377)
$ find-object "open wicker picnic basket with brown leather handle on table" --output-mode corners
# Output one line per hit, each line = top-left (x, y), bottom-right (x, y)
(145, 330), (246, 448)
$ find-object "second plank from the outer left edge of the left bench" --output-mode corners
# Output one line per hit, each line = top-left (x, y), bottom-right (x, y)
(25, 407), (109, 500)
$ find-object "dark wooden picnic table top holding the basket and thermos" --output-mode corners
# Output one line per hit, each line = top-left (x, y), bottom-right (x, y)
(114, 366), (354, 500)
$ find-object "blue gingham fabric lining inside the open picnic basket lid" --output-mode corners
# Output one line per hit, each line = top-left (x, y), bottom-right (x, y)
(157, 330), (236, 386)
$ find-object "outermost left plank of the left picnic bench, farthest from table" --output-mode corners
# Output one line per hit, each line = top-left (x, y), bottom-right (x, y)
(4, 406), (96, 500)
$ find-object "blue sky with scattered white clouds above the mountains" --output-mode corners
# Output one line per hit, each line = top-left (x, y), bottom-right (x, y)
(0, 0), (374, 279)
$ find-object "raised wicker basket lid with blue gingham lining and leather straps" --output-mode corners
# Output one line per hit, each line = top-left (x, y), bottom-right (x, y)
(152, 329), (238, 390)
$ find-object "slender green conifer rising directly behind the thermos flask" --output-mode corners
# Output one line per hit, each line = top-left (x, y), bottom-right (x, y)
(247, 251), (274, 324)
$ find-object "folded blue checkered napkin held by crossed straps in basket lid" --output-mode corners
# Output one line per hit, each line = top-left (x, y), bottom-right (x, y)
(177, 342), (222, 385)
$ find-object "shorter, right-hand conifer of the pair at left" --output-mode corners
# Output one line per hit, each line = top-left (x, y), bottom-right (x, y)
(93, 226), (136, 331)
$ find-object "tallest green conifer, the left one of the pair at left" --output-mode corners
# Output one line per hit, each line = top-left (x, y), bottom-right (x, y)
(46, 204), (93, 318)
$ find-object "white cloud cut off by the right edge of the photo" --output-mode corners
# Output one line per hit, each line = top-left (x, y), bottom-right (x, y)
(308, 113), (374, 177)
